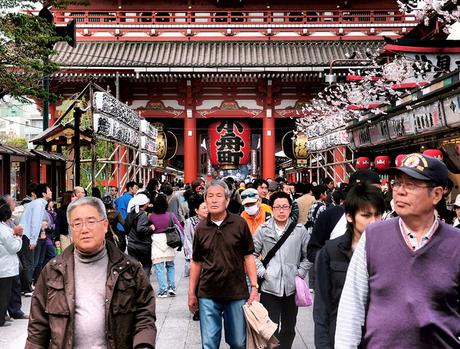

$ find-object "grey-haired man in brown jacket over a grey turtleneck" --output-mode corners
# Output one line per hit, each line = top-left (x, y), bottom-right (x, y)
(25, 197), (156, 349)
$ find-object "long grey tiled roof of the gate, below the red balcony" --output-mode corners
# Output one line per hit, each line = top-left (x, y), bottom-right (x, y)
(53, 41), (384, 68)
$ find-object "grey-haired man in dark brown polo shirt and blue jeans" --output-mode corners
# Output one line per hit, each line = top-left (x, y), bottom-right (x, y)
(188, 180), (258, 349)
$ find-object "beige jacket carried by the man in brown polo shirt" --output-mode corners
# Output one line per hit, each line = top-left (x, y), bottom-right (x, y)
(243, 301), (279, 349)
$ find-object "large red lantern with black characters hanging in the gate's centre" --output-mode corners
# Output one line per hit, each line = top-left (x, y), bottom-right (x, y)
(208, 119), (251, 169)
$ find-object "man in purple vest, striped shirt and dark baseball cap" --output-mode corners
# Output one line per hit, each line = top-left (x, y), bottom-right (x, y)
(335, 154), (460, 349)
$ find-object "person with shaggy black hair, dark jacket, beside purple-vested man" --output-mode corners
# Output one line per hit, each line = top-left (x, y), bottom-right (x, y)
(313, 183), (385, 349)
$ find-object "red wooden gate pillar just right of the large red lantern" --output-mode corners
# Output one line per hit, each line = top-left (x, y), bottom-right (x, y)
(262, 80), (275, 179)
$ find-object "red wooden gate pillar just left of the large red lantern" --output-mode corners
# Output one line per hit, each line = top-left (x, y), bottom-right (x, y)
(184, 80), (199, 183)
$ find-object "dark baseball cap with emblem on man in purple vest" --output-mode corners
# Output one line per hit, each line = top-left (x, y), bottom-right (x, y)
(388, 153), (449, 187)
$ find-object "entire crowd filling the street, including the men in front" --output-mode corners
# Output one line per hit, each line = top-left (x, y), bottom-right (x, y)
(0, 154), (460, 349)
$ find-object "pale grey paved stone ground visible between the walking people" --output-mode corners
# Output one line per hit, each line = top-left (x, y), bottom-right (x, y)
(0, 254), (314, 349)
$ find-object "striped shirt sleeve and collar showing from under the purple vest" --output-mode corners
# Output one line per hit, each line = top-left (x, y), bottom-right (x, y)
(335, 218), (439, 349)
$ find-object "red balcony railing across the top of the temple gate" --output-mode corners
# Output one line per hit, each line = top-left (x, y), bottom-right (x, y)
(23, 9), (417, 40)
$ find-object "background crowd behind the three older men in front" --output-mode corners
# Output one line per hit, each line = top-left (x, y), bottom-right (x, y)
(0, 162), (460, 348)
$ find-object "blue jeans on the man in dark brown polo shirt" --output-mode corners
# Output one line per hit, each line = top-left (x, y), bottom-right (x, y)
(199, 298), (246, 349)
